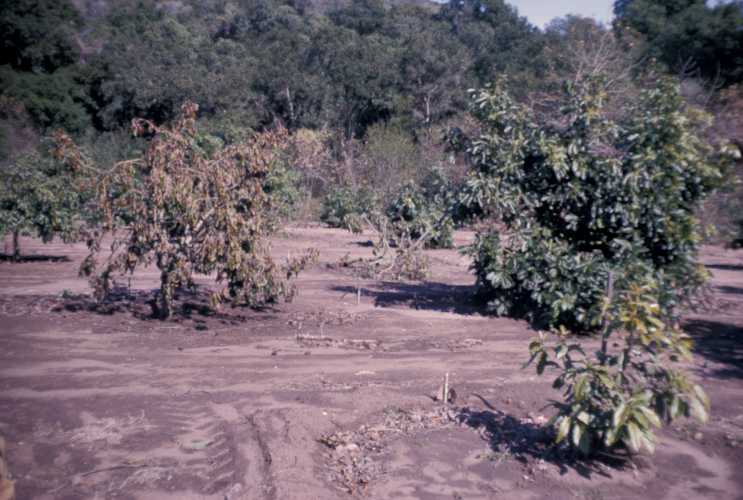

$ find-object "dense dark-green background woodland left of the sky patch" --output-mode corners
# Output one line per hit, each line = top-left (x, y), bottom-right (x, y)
(0, 0), (541, 145)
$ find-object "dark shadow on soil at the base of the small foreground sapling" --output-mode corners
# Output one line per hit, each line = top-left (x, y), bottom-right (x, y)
(457, 404), (629, 479)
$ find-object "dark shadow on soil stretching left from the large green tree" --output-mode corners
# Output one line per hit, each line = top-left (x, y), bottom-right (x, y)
(333, 281), (488, 315)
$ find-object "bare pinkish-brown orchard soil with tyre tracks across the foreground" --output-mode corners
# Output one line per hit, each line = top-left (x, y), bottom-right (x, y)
(0, 228), (743, 500)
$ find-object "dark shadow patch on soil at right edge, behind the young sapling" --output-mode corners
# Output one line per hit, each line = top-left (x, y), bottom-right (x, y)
(684, 319), (743, 378)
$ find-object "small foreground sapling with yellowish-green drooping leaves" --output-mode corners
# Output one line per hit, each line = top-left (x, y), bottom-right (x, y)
(529, 283), (709, 456)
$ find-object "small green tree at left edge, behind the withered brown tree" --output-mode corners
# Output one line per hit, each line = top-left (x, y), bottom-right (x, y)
(0, 146), (83, 259)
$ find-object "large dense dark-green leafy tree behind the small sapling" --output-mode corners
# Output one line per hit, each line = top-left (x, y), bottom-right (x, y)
(461, 79), (725, 330)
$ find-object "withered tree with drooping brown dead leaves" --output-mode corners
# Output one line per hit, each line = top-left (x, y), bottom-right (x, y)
(57, 103), (314, 318)
